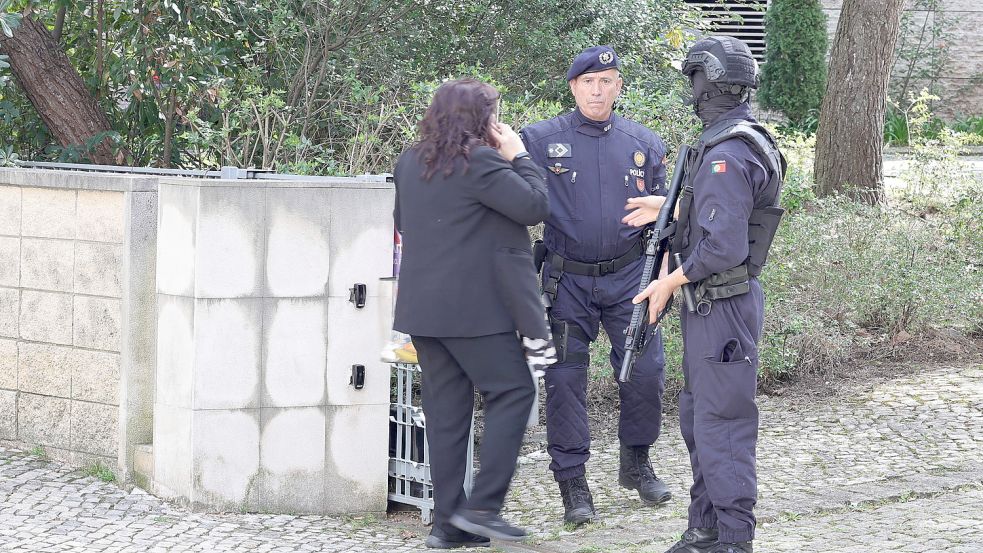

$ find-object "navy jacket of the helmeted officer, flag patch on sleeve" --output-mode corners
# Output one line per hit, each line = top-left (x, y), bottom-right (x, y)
(683, 104), (775, 282)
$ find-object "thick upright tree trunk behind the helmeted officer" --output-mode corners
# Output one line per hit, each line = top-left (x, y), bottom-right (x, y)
(815, 0), (904, 203)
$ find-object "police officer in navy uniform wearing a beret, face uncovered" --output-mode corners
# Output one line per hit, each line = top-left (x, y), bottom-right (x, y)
(521, 46), (671, 524)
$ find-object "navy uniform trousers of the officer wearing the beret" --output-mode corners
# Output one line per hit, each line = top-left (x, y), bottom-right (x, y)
(543, 258), (665, 482)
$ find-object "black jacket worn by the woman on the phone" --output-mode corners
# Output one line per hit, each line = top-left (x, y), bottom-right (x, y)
(393, 146), (549, 338)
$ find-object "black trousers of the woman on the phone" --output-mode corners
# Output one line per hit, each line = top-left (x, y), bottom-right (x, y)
(413, 332), (536, 535)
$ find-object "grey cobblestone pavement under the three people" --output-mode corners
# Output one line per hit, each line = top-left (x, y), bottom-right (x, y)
(0, 365), (983, 553)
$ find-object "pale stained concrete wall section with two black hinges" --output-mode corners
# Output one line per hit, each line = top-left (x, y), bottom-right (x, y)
(153, 179), (394, 513)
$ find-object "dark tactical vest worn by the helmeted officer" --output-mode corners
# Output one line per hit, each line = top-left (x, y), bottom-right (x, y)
(670, 119), (788, 284)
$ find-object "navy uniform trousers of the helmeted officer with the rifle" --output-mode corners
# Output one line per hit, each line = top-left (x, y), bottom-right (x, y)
(679, 278), (764, 543)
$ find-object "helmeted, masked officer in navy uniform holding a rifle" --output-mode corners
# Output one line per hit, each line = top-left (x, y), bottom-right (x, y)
(634, 36), (785, 553)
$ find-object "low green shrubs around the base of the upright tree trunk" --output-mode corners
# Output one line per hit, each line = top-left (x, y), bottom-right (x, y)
(760, 121), (983, 381)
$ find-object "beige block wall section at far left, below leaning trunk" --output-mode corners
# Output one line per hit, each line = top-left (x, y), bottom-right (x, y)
(0, 169), (156, 478)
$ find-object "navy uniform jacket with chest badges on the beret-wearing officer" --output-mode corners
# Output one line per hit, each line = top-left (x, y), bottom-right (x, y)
(521, 110), (666, 263)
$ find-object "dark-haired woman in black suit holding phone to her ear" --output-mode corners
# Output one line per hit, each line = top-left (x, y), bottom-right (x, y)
(393, 79), (549, 549)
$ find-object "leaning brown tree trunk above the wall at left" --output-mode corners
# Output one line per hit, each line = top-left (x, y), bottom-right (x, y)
(0, 15), (123, 165)
